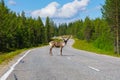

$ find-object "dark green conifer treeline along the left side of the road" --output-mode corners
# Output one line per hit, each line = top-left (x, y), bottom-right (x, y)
(0, 0), (56, 52)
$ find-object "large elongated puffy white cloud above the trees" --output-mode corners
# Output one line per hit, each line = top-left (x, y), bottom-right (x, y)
(31, 0), (89, 18)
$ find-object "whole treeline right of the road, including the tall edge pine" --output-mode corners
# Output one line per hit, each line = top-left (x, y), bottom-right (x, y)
(59, 0), (120, 54)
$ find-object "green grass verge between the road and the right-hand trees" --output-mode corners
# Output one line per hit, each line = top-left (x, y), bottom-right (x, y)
(73, 39), (120, 57)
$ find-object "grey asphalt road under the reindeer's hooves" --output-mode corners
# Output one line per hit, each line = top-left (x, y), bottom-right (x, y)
(1, 40), (120, 80)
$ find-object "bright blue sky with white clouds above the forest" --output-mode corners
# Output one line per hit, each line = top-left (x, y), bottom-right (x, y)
(5, 0), (105, 23)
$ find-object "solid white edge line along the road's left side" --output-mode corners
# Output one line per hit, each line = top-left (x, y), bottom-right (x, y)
(0, 50), (31, 80)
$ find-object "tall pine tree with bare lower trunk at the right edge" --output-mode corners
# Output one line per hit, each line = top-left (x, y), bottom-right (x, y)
(102, 0), (120, 54)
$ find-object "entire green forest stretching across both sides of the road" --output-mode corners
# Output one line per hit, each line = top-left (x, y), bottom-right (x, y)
(0, 0), (120, 54)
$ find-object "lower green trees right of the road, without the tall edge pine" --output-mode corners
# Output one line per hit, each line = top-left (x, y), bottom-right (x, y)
(59, 17), (113, 51)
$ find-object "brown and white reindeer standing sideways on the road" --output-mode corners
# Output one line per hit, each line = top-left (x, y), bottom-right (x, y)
(49, 36), (71, 56)
